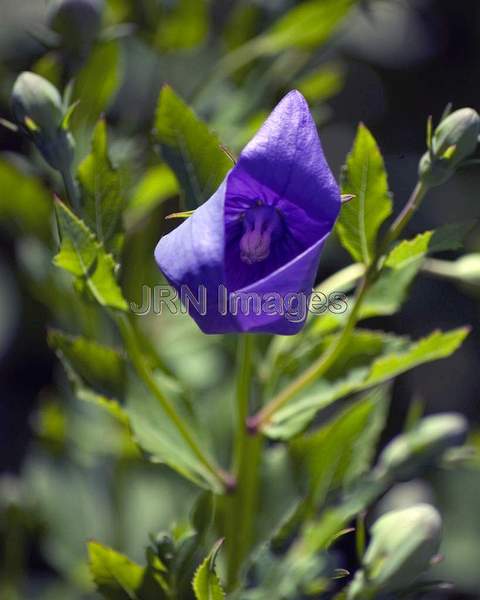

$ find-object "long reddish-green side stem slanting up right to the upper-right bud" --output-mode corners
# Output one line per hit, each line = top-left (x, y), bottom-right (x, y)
(248, 181), (428, 432)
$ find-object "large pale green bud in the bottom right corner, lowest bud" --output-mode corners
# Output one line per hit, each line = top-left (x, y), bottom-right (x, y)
(348, 504), (442, 600)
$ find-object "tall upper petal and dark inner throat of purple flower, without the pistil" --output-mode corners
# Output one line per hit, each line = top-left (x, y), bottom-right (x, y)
(225, 91), (341, 289)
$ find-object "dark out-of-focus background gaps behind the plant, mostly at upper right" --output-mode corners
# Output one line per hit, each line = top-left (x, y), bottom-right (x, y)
(0, 0), (480, 597)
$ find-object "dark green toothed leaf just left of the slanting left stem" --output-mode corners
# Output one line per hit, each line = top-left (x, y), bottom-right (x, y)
(48, 329), (126, 398)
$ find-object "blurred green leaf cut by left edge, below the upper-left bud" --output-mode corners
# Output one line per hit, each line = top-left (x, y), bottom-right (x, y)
(0, 160), (52, 239)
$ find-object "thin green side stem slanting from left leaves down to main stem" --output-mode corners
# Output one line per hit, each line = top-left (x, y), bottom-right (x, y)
(116, 315), (232, 489)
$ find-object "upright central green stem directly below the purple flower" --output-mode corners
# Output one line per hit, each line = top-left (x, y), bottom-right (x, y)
(227, 335), (263, 590)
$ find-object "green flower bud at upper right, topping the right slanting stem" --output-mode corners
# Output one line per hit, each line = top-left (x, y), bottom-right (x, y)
(419, 108), (480, 186)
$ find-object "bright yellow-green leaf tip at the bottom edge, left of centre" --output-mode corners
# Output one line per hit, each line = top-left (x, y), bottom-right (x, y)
(88, 542), (145, 600)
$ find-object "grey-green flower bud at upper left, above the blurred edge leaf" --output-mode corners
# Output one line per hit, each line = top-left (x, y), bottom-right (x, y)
(11, 72), (74, 171)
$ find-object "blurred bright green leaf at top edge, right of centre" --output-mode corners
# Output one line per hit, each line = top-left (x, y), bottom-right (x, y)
(258, 0), (355, 53)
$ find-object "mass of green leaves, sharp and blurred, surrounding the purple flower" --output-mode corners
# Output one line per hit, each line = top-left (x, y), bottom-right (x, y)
(0, 0), (480, 600)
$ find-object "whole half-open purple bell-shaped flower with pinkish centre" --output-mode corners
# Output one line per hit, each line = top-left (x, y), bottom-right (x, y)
(155, 91), (341, 335)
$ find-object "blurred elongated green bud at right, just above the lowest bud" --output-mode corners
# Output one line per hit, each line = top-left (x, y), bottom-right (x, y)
(378, 413), (468, 480)
